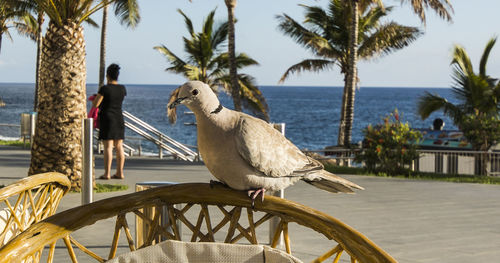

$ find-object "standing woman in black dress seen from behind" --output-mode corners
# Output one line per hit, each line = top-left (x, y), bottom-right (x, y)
(92, 64), (127, 180)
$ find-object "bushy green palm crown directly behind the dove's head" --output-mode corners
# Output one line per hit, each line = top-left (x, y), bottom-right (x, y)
(154, 10), (269, 120)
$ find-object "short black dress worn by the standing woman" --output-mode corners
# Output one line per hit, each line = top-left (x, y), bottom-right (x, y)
(98, 84), (127, 140)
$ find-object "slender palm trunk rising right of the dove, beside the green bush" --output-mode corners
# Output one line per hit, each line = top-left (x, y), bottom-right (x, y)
(338, 0), (359, 146)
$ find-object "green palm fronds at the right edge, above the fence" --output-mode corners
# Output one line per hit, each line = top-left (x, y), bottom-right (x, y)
(418, 38), (500, 151)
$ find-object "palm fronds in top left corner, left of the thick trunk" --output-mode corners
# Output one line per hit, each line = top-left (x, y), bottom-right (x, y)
(0, 1), (36, 52)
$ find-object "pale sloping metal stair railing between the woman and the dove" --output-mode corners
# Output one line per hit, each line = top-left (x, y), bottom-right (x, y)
(123, 111), (199, 162)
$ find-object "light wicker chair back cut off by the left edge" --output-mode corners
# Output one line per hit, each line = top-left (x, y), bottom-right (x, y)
(0, 173), (71, 249)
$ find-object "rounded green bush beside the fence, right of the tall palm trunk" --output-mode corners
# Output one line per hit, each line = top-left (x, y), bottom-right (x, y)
(355, 109), (422, 175)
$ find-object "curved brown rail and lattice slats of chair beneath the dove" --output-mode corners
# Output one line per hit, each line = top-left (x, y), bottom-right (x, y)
(0, 183), (396, 263)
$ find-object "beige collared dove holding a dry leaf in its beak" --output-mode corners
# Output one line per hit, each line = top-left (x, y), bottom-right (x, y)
(167, 81), (364, 206)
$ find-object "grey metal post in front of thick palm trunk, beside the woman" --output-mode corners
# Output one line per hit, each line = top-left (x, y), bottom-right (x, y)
(82, 118), (94, 205)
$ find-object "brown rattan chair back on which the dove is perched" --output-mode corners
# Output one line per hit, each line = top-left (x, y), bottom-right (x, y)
(0, 183), (396, 263)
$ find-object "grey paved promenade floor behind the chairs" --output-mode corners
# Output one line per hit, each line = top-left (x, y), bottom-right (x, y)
(0, 146), (500, 263)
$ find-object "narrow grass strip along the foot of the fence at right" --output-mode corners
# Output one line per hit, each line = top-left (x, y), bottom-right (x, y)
(325, 165), (500, 184)
